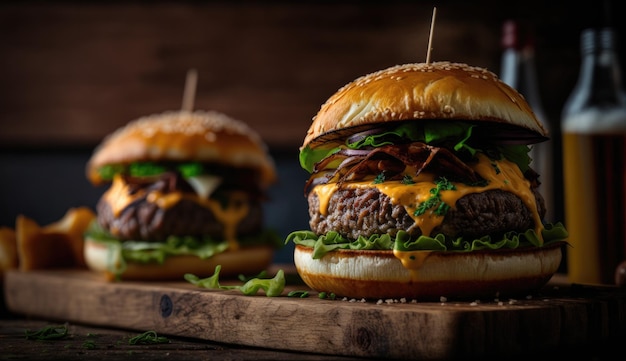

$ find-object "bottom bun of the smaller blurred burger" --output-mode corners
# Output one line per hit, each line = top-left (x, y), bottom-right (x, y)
(84, 239), (275, 281)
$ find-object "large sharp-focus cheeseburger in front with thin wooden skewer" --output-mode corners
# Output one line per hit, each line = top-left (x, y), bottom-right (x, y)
(285, 62), (567, 299)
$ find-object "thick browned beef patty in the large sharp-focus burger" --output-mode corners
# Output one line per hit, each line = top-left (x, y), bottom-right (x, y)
(308, 188), (545, 239)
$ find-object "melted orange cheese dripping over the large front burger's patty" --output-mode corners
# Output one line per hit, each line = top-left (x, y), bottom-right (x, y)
(313, 153), (543, 239)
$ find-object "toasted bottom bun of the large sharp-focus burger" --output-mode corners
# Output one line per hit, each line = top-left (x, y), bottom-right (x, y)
(294, 243), (562, 300)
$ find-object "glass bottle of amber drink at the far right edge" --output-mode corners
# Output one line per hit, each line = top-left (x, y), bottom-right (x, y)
(561, 28), (626, 284)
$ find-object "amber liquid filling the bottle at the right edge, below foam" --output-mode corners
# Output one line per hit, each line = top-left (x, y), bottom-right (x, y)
(563, 129), (626, 284)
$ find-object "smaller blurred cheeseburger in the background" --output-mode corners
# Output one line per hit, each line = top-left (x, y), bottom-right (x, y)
(84, 111), (282, 280)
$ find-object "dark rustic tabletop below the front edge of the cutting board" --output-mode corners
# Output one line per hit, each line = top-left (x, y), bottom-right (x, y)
(0, 316), (363, 361)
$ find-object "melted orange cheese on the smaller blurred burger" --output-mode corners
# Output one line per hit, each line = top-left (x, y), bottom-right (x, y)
(103, 175), (250, 250)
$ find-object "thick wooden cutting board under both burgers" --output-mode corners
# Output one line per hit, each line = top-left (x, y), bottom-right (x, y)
(4, 270), (626, 360)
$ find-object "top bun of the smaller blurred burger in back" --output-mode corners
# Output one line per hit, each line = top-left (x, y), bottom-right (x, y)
(87, 111), (277, 186)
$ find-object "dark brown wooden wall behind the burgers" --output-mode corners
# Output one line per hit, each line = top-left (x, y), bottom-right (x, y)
(0, 0), (620, 147)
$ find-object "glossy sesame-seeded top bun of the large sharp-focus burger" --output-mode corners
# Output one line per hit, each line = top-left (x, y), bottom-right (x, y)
(302, 62), (547, 148)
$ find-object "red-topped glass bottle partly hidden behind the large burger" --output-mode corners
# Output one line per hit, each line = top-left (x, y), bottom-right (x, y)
(500, 20), (555, 222)
